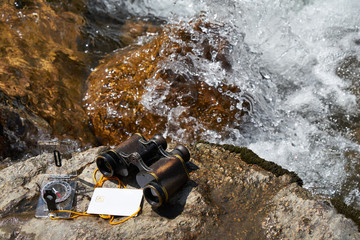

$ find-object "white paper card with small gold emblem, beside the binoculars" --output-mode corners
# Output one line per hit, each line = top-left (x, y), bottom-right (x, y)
(87, 188), (143, 216)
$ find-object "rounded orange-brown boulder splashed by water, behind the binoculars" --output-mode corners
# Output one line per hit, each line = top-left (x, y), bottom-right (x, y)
(84, 20), (250, 144)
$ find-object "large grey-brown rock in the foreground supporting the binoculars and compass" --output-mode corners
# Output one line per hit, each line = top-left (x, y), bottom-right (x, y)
(0, 143), (360, 239)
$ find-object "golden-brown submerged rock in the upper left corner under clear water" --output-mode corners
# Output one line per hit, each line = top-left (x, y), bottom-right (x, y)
(0, 0), (94, 157)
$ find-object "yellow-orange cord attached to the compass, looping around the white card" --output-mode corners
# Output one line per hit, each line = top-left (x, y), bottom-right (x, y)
(50, 168), (141, 225)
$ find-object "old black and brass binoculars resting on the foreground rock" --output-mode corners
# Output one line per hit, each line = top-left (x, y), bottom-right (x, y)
(96, 133), (190, 207)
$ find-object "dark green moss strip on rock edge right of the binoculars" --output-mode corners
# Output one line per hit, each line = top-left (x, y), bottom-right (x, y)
(200, 141), (303, 186)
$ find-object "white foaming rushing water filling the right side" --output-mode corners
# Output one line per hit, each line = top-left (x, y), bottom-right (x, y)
(86, 0), (360, 207)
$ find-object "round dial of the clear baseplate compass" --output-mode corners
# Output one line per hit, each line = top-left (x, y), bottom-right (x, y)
(41, 180), (72, 203)
